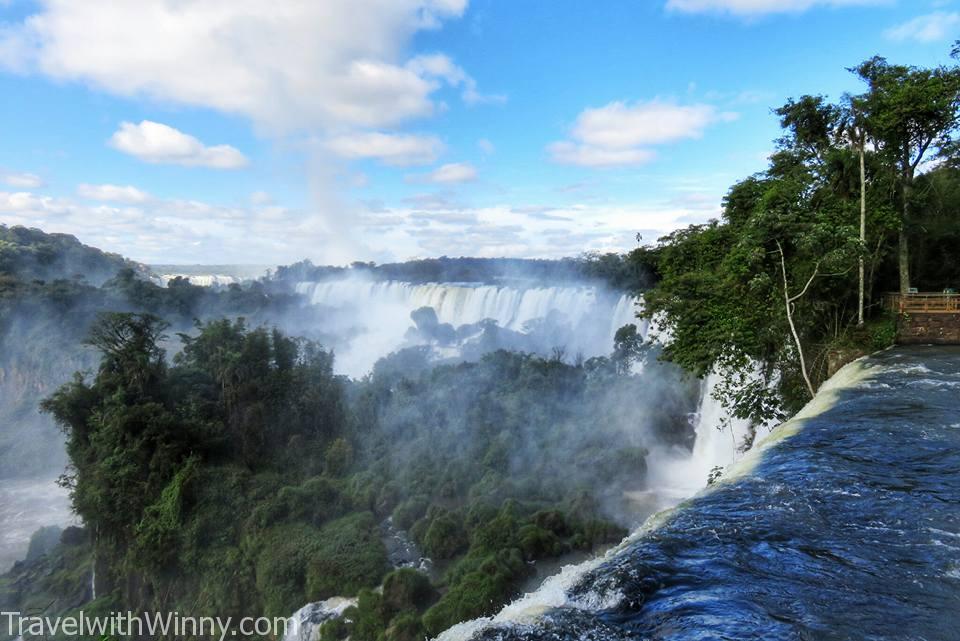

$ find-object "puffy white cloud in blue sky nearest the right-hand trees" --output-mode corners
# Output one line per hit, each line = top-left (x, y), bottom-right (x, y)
(547, 100), (736, 167)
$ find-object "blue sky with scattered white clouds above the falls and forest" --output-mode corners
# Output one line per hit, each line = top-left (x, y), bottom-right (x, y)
(0, 0), (960, 265)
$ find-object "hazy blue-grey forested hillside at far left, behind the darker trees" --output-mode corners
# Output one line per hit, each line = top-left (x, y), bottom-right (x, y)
(0, 225), (325, 478)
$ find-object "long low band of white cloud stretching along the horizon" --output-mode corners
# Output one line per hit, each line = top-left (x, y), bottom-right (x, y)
(0, 179), (720, 264)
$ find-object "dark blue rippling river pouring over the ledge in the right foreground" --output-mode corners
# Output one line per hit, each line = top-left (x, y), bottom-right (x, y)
(442, 348), (960, 641)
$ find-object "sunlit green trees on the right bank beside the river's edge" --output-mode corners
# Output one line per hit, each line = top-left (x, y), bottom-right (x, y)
(631, 50), (960, 421)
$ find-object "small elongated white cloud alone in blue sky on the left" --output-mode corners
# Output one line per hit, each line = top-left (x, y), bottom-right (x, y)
(108, 120), (247, 169)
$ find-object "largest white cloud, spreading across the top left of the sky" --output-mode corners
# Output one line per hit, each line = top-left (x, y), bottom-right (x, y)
(0, 0), (479, 131)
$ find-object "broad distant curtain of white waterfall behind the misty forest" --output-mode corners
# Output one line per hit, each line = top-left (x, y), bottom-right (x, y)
(296, 278), (646, 376)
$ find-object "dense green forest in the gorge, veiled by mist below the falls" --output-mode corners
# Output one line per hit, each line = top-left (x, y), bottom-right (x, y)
(0, 313), (696, 639)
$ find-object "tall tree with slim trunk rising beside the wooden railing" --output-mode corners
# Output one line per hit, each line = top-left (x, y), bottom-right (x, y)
(851, 56), (960, 294)
